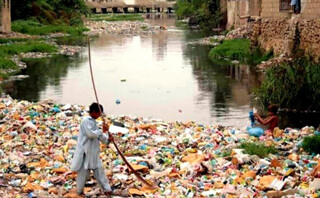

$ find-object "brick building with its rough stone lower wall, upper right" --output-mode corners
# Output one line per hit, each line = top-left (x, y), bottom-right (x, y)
(227, 0), (320, 60)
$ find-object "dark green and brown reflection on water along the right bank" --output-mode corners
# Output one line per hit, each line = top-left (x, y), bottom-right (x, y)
(184, 42), (261, 125)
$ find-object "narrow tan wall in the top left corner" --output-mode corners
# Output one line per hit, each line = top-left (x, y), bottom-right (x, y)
(0, 0), (11, 33)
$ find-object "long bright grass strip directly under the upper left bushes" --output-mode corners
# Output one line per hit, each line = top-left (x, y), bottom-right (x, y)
(12, 20), (88, 35)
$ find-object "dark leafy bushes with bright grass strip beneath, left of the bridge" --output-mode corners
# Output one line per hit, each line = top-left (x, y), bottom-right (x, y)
(11, 0), (90, 35)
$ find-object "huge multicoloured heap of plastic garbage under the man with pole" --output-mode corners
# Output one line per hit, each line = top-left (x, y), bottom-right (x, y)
(0, 97), (320, 198)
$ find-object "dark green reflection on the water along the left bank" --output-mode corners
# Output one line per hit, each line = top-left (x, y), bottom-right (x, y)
(2, 55), (87, 101)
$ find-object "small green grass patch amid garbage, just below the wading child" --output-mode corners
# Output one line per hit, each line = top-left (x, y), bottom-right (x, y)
(240, 142), (277, 158)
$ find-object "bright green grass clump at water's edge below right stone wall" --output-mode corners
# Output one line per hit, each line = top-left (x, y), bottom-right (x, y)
(209, 39), (250, 61)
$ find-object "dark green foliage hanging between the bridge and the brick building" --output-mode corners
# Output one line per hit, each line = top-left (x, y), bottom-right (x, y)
(176, 0), (223, 31)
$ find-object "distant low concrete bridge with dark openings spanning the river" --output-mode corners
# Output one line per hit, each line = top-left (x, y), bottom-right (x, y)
(85, 0), (176, 13)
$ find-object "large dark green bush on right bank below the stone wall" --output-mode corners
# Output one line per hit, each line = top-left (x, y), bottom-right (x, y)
(254, 57), (320, 111)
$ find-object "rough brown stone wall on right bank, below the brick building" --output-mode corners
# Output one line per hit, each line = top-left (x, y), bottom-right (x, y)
(251, 16), (320, 59)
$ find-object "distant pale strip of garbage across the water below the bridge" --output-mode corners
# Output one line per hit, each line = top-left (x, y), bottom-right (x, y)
(84, 21), (166, 36)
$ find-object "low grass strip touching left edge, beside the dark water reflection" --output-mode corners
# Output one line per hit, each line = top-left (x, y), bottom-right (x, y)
(0, 41), (57, 57)
